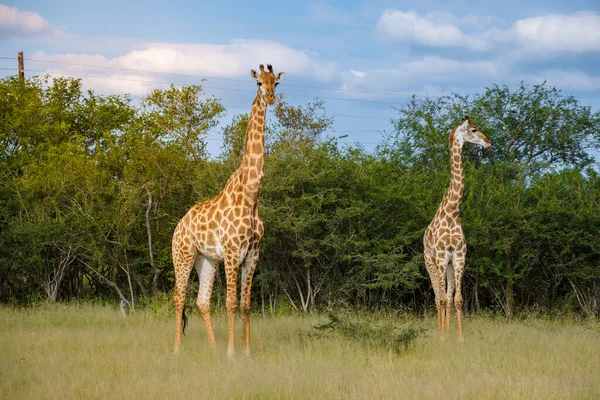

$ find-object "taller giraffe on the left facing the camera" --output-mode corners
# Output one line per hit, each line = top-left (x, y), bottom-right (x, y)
(172, 64), (284, 358)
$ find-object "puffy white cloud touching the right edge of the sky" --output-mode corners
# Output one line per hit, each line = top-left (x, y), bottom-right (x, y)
(513, 11), (600, 52)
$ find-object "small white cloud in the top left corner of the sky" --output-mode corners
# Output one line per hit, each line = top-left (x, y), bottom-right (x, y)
(0, 4), (62, 38)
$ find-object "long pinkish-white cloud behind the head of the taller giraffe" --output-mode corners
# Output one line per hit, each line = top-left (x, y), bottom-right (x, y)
(32, 40), (336, 96)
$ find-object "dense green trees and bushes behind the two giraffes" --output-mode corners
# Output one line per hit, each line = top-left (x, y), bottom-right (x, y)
(0, 77), (600, 316)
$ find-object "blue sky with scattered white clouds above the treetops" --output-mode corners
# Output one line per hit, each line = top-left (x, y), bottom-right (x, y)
(0, 0), (600, 154)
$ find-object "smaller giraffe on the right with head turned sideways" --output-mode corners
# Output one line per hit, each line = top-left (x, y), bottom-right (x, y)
(423, 116), (492, 342)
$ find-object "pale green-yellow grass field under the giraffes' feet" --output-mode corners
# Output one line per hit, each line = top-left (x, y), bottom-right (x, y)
(0, 305), (600, 400)
